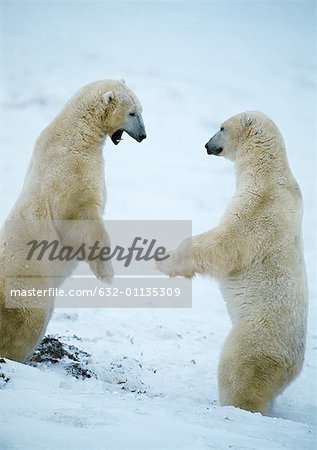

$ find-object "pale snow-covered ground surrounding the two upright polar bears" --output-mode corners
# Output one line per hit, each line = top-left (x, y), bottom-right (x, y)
(0, 0), (317, 450)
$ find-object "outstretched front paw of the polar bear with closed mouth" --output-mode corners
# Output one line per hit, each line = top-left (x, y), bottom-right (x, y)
(156, 239), (195, 278)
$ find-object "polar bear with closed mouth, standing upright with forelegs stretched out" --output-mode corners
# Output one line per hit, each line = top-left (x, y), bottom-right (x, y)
(158, 112), (307, 414)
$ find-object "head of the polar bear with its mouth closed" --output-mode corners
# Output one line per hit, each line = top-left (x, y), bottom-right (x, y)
(205, 111), (282, 161)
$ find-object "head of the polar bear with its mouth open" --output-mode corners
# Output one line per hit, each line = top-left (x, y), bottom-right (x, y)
(77, 80), (146, 145)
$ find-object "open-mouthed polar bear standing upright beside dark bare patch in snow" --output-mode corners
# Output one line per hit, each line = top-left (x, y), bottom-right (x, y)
(0, 80), (146, 361)
